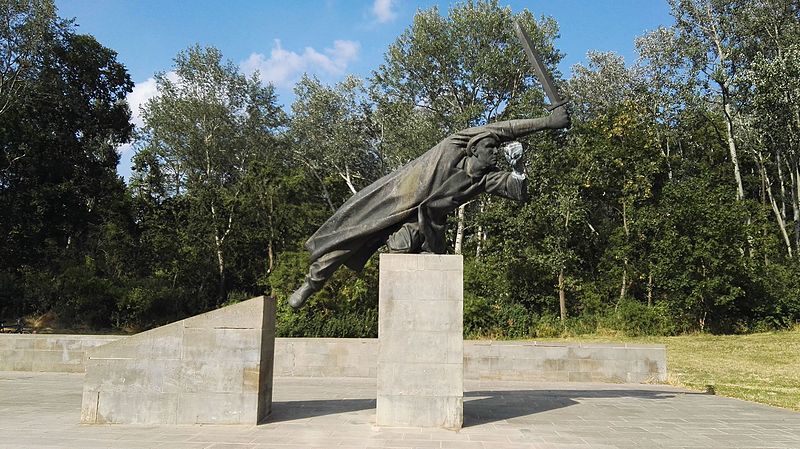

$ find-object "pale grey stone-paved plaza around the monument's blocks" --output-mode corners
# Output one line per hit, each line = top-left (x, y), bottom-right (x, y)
(0, 372), (800, 449)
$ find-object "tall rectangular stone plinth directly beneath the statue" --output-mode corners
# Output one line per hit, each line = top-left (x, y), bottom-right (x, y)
(376, 254), (464, 429)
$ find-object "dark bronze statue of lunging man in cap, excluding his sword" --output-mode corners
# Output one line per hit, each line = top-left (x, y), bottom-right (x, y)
(289, 105), (570, 308)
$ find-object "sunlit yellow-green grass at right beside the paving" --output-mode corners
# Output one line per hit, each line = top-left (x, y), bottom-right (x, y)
(552, 328), (800, 411)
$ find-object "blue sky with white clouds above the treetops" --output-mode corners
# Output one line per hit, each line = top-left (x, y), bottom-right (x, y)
(56, 0), (672, 178)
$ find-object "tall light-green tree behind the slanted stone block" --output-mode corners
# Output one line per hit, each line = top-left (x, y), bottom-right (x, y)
(135, 46), (284, 304)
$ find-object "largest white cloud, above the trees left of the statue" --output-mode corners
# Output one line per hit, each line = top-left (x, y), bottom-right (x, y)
(241, 39), (361, 87)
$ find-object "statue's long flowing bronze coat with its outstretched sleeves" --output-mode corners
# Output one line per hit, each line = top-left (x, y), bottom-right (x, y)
(306, 118), (550, 270)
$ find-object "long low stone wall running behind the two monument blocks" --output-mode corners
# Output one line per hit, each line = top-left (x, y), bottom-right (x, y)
(0, 334), (667, 383)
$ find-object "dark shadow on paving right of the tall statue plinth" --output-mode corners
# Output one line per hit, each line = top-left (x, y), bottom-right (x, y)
(464, 390), (675, 427)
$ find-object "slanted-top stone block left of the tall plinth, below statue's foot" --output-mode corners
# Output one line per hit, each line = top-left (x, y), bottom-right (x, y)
(81, 296), (275, 424)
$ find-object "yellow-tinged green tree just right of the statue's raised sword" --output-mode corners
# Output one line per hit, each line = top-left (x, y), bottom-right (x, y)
(569, 53), (664, 304)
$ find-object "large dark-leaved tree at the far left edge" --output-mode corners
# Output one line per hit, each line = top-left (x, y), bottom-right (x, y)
(0, 2), (133, 326)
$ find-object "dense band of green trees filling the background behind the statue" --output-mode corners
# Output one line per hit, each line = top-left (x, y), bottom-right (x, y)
(0, 0), (800, 338)
